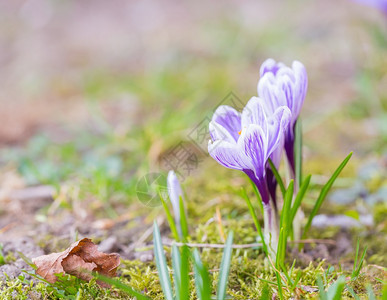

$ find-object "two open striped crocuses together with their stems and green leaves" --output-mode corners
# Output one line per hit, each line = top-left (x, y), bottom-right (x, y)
(208, 59), (351, 264)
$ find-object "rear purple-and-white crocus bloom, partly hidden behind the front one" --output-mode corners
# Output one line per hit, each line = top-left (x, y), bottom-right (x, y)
(257, 58), (308, 182)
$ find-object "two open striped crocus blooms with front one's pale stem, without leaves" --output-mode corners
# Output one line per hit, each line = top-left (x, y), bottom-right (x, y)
(208, 59), (308, 258)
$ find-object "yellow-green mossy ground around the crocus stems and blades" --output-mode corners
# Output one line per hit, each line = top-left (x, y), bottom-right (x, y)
(0, 162), (387, 299)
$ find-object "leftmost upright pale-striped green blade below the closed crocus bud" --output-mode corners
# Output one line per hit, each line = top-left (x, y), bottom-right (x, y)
(153, 221), (173, 300)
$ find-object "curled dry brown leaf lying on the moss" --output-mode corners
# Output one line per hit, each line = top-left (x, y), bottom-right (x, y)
(32, 238), (120, 287)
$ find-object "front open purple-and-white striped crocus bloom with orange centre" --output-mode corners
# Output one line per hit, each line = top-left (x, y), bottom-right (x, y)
(208, 97), (291, 207)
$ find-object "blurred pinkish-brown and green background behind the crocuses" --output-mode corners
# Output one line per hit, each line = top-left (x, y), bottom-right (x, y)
(0, 0), (387, 255)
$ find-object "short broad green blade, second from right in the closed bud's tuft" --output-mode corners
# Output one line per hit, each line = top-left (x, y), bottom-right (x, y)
(192, 249), (211, 300)
